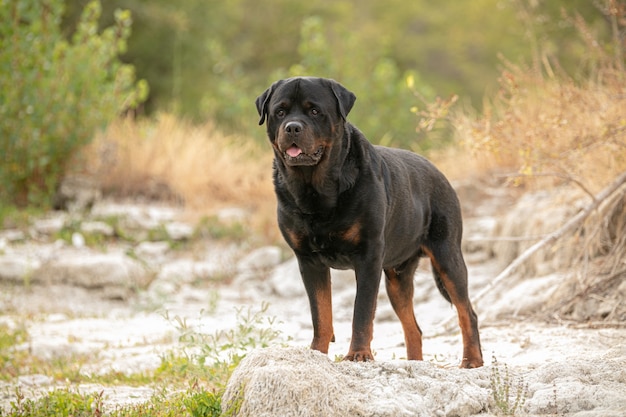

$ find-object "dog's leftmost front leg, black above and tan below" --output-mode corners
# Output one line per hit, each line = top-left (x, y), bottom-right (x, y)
(298, 258), (335, 353)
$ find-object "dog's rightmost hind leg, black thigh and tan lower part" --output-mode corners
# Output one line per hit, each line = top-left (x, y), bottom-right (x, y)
(422, 240), (483, 368)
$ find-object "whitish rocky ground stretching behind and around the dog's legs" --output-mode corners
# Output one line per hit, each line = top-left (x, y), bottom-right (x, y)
(0, 189), (626, 416)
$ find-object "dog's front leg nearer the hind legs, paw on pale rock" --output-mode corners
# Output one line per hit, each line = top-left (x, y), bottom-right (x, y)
(344, 257), (382, 362)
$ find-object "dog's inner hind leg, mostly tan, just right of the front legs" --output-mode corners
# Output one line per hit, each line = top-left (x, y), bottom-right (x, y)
(385, 258), (423, 361)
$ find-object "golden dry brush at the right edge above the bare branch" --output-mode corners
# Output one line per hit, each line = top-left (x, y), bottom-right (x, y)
(454, 64), (626, 193)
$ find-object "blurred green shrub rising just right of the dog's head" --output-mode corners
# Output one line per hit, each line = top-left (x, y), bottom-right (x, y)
(287, 16), (434, 150)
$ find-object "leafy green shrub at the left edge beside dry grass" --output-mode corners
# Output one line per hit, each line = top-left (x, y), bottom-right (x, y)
(0, 0), (147, 206)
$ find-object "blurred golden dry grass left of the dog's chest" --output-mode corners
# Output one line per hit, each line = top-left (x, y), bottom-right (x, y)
(83, 114), (277, 240)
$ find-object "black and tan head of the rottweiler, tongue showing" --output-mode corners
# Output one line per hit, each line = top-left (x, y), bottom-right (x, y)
(256, 77), (356, 166)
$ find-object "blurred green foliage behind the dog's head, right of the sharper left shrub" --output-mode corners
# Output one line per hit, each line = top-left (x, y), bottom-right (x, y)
(63, 0), (611, 143)
